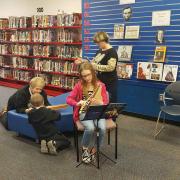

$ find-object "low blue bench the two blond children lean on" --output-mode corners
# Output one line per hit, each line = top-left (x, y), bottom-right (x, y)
(8, 93), (73, 139)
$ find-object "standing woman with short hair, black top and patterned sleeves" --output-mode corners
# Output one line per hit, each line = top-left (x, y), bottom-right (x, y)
(75, 32), (118, 103)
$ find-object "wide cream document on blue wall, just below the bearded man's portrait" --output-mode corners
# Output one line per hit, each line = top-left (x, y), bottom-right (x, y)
(125, 26), (140, 39)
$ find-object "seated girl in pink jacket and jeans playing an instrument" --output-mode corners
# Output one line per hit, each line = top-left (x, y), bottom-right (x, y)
(66, 62), (108, 163)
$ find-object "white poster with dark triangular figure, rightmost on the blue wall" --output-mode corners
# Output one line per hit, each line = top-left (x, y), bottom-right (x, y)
(162, 64), (178, 82)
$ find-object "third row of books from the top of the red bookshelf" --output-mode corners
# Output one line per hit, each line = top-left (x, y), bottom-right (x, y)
(0, 44), (82, 58)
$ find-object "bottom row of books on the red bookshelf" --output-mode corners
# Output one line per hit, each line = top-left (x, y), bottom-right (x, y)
(0, 68), (79, 89)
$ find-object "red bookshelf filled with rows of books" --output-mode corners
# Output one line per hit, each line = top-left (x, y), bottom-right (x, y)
(0, 12), (82, 96)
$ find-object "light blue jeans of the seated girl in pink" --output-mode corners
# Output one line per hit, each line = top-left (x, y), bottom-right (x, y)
(80, 113), (106, 148)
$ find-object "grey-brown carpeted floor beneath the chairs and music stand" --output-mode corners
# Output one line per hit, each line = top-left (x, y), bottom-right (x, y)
(0, 115), (180, 180)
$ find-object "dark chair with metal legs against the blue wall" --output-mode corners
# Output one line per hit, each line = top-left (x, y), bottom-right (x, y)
(154, 81), (180, 138)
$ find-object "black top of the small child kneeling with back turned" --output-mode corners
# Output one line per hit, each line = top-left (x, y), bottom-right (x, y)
(28, 107), (61, 139)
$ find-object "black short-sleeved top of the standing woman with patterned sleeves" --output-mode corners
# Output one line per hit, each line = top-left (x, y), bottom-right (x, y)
(95, 48), (118, 86)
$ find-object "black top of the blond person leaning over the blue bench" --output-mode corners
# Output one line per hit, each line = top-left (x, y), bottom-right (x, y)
(7, 85), (50, 113)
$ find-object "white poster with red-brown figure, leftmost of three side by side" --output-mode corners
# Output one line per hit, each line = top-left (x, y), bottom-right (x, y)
(137, 62), (152, 80)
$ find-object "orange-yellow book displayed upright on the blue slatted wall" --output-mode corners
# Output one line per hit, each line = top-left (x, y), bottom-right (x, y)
(154, 46), (166, 62)
